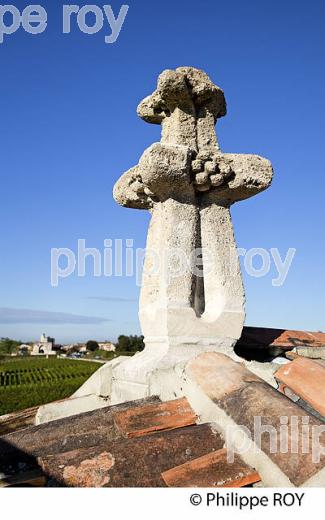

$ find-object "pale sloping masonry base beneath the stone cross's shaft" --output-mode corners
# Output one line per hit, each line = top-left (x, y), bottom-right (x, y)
(36, 337), (240, 424)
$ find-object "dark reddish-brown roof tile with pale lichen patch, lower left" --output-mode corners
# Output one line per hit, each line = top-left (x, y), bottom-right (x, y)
(40, 424), (224, 487)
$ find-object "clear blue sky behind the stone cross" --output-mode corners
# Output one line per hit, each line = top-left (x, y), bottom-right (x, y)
(0, 0), (325, 342)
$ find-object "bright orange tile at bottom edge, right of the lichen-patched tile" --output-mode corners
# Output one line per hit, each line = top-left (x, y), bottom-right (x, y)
(162, 448), (261, 488)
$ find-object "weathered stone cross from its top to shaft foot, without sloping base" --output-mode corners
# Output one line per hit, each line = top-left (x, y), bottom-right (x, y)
(114, 67), (273, 361)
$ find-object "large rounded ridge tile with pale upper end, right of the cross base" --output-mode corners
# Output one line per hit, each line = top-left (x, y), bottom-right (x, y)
(187, 352), (325, 486)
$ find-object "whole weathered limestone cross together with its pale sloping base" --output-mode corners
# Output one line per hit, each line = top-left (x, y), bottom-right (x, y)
(36, 71), (273, 416)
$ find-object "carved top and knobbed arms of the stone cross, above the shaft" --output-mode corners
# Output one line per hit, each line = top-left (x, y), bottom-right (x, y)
(114, 67), (272, 209)
